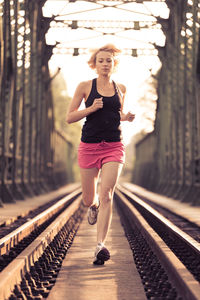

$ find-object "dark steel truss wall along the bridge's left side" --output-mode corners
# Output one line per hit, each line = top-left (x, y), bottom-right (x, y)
(0, 0), (73, 205)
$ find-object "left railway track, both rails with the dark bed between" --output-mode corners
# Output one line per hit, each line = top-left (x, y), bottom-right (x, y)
(0, 188), (85, 300)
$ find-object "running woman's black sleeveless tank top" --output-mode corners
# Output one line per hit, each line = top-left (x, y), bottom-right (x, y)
(81, 78), (121, 143)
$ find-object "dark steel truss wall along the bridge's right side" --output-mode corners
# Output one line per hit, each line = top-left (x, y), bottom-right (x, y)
(133, 0), (200, 204)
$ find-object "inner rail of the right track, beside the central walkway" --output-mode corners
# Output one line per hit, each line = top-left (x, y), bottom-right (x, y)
(115, 186), (200, 300)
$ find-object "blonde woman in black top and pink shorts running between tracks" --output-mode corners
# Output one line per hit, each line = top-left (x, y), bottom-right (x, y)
(67, 44), (135, 265)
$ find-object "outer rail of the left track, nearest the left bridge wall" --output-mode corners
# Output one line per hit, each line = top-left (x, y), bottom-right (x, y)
(0, 188), (81, 255)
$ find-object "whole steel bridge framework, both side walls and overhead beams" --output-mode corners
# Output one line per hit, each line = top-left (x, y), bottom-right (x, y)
(0, 0), (200, 206)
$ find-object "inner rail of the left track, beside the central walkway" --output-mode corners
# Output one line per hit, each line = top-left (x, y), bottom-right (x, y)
(0, 192), (81, 300)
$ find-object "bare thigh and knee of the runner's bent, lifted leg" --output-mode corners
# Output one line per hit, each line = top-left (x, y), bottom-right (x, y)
(80, 168), (99, 207)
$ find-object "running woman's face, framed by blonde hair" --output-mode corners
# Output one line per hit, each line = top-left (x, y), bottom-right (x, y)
(96, 51), (114, 76)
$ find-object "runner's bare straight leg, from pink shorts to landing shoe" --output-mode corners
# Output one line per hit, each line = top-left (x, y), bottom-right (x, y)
(97, 162), (123, 243)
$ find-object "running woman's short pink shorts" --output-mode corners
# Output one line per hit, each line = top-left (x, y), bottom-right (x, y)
(78, 141), (125, 169)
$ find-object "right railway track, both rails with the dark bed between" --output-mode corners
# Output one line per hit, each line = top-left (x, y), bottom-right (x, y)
(116, 186), (200, 300)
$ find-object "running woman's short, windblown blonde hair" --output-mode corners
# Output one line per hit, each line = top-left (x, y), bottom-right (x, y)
(88, 44), (121, 69)
